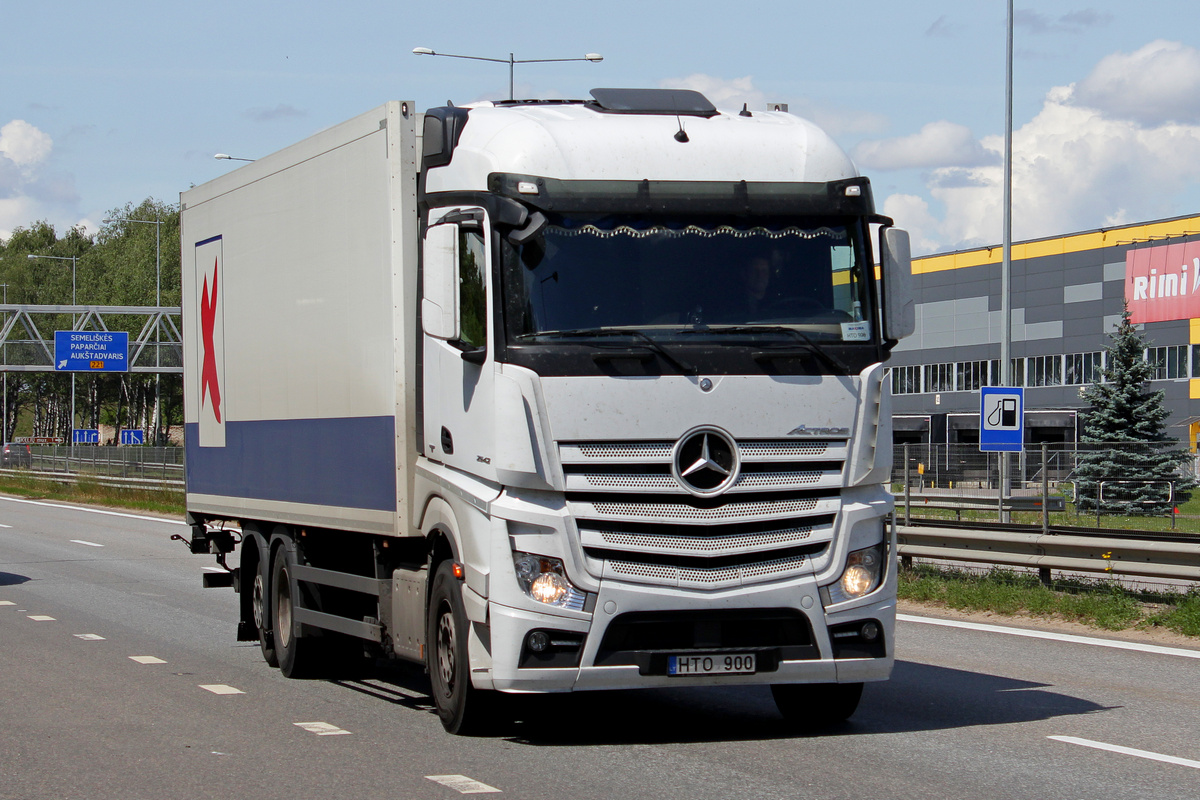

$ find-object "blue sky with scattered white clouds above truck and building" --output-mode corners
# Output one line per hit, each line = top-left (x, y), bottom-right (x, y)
(0, 0), (1200, 253)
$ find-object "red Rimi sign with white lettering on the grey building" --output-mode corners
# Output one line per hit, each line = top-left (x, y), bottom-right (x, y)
(1126, 241), (1200, 324)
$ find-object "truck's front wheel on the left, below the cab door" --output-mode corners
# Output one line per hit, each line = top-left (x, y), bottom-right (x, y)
(425, 561), (494, 735)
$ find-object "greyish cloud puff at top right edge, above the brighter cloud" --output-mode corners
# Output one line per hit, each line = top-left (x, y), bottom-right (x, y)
(1075, 40), (1200, 125)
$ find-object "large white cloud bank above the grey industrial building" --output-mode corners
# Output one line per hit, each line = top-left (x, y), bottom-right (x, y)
(854, 42), (1200, 253)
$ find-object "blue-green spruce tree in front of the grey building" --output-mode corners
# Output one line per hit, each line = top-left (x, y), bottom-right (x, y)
(1075, 308), (1196, 515)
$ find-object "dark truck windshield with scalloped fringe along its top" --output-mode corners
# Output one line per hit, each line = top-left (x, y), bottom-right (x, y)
(504, 217), (875, 343)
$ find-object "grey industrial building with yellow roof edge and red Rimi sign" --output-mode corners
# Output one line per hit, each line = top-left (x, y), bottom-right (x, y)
(889, 216), (1200, 450)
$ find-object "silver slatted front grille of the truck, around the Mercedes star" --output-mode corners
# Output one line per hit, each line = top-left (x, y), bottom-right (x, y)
(559, 440), (848, 589)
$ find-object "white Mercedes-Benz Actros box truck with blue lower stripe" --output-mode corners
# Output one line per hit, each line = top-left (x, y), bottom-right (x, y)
(181, 89), (913, 733)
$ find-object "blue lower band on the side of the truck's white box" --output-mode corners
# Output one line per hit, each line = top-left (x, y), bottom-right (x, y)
(184, 416), (396, 511)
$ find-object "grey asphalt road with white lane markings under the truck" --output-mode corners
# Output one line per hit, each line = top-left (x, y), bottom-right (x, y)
(0, 498), (1200, 800)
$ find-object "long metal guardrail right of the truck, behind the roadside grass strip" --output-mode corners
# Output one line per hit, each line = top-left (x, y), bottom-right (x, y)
(896, 525), (1200, 581)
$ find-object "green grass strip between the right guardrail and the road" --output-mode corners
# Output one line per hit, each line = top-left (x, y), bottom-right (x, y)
(899, 564), (1200, 637)
